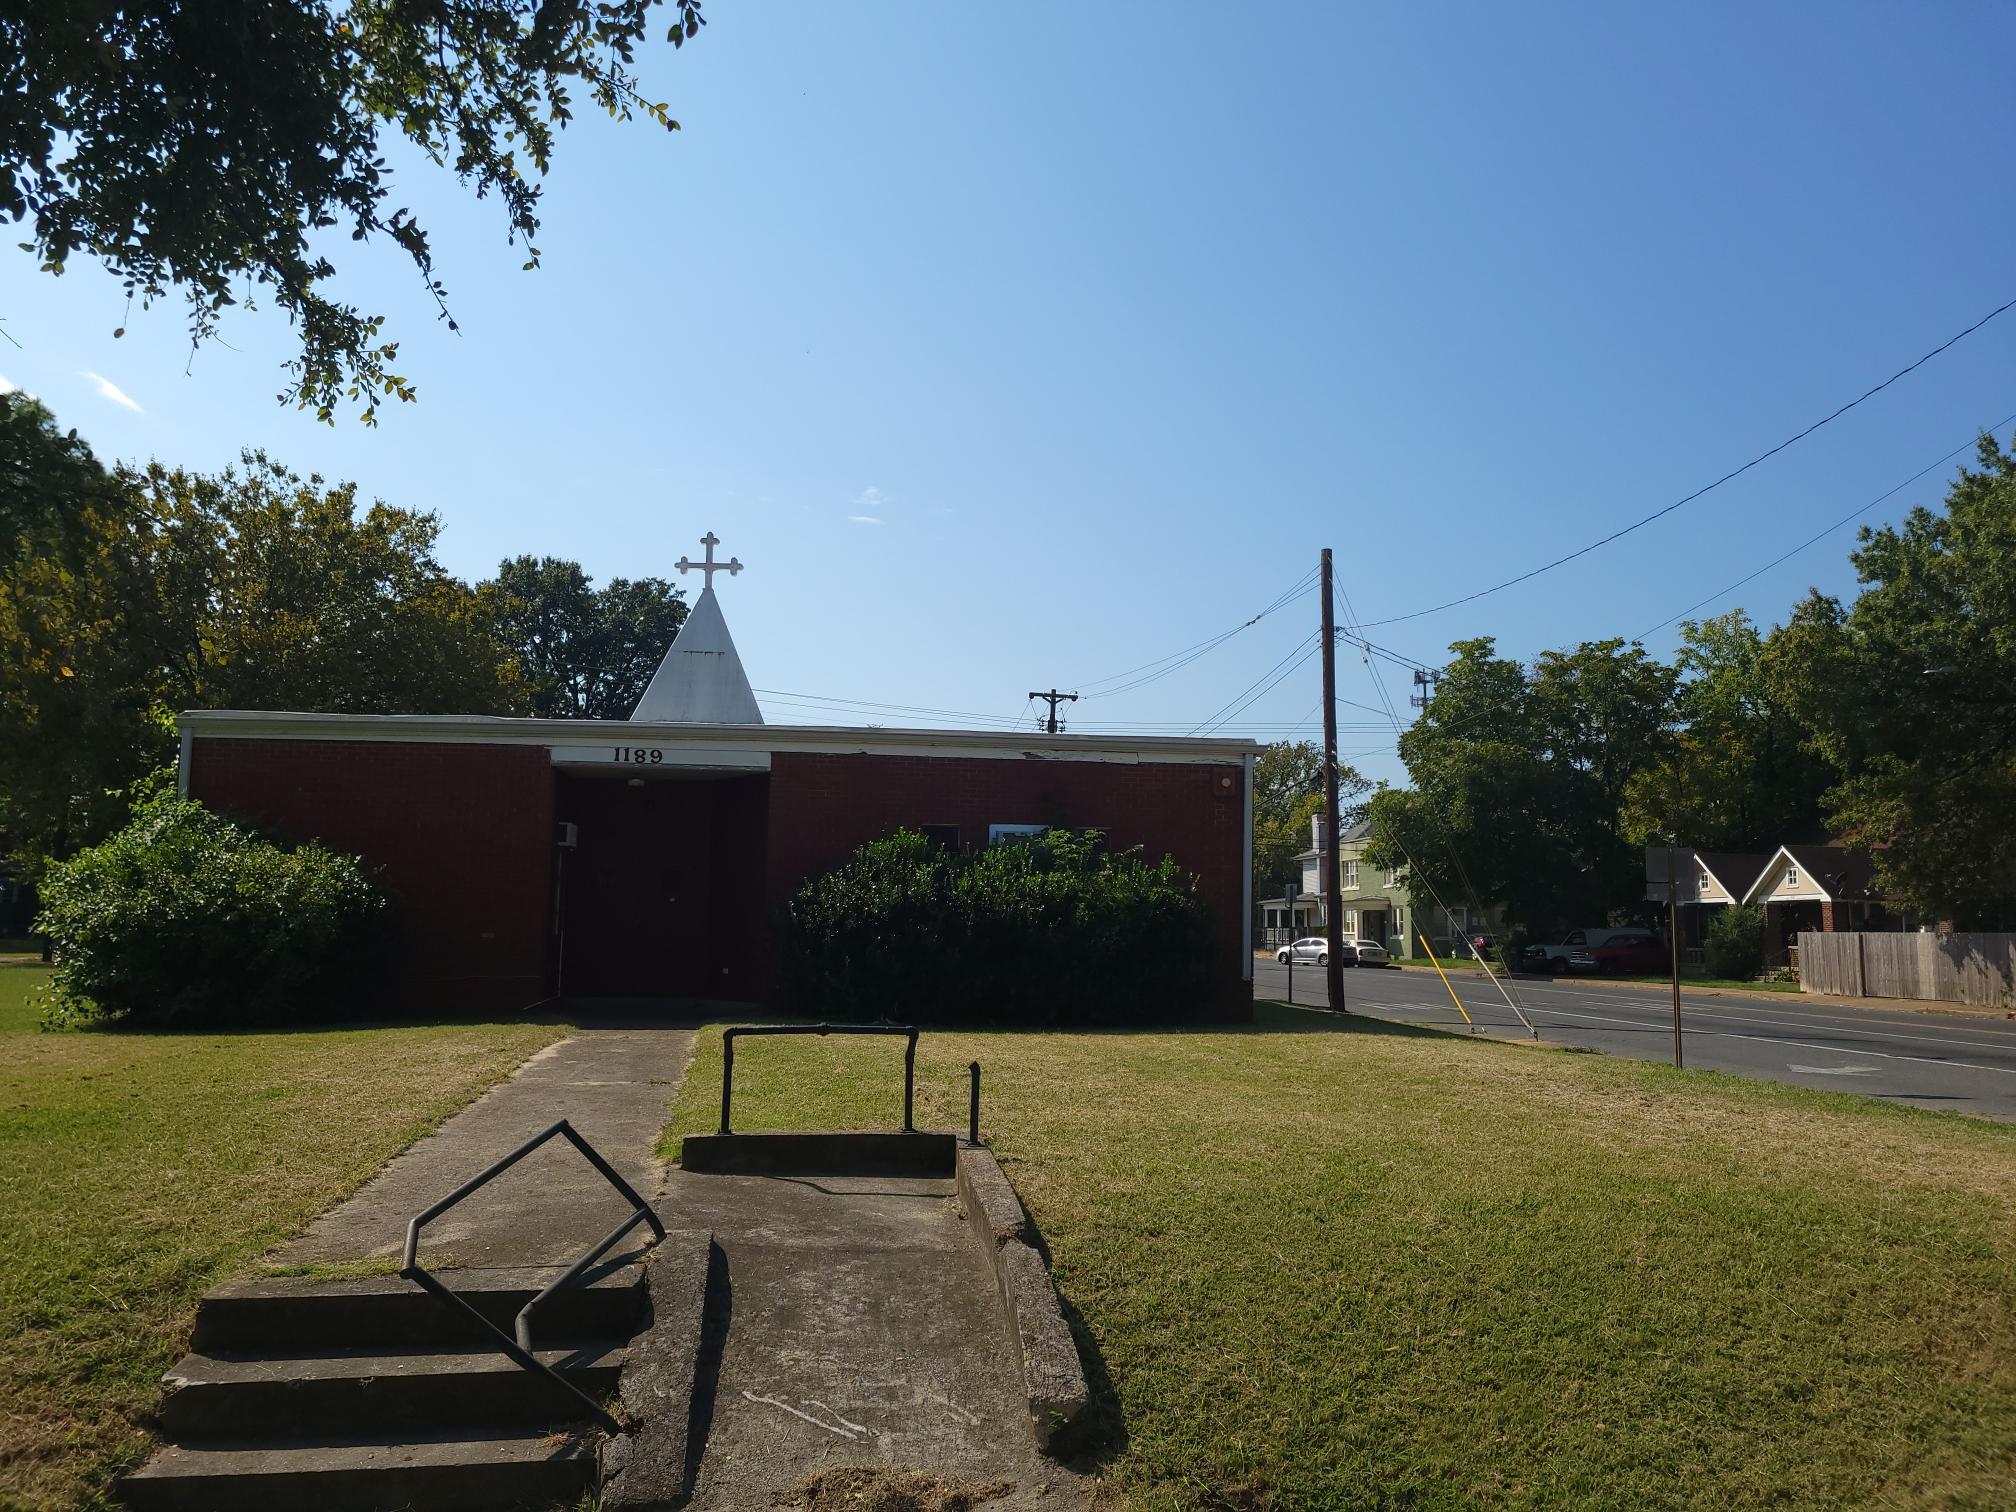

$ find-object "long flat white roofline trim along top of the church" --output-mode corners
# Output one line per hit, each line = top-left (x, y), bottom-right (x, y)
(175, 710), (1260, 766)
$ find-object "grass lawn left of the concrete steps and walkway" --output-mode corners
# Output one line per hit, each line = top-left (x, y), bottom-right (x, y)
(0, 966), (564, 1508)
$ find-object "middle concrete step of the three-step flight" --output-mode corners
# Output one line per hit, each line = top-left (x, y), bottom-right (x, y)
(161, 1341), (623, 1441)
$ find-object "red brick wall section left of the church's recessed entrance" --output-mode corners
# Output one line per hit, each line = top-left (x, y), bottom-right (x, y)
(190, 738), (554, 1012)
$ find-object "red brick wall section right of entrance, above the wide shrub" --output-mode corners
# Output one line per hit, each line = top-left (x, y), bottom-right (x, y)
(768, 752), (1252, 1018)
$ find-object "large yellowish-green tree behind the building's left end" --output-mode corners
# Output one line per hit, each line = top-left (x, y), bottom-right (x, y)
(0, 395), (524, 863)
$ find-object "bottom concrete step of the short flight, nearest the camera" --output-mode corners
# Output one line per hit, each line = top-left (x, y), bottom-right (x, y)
(121, 1429), (595, 1512)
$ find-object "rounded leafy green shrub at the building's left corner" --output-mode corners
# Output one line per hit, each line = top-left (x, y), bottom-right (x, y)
(36, 796), (387, 1024)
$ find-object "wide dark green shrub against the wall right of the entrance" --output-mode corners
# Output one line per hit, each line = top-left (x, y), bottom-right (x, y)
(780, 831), (1214, 1024)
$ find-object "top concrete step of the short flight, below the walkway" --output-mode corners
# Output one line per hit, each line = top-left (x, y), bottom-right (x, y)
(190, 1262), (643, 1353)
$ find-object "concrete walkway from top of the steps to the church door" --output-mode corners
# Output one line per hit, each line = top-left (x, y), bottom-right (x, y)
(268, 1028), (694, 1268)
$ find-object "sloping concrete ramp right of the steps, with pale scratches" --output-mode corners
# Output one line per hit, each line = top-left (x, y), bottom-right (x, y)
(661, 1135), (1085, 1512)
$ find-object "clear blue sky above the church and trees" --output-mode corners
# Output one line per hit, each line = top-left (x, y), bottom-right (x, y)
(0, 0), (2016, 778)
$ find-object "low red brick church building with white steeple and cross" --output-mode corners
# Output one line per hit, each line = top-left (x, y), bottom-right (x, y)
(179, 538), (1256, 1016)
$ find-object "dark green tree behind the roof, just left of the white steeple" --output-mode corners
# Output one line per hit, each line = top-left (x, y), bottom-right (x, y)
(484, 556), (685, 720)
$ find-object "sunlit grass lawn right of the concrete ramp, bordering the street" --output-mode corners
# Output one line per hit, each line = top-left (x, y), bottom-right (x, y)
(667, 1006), (2016, 1510)
